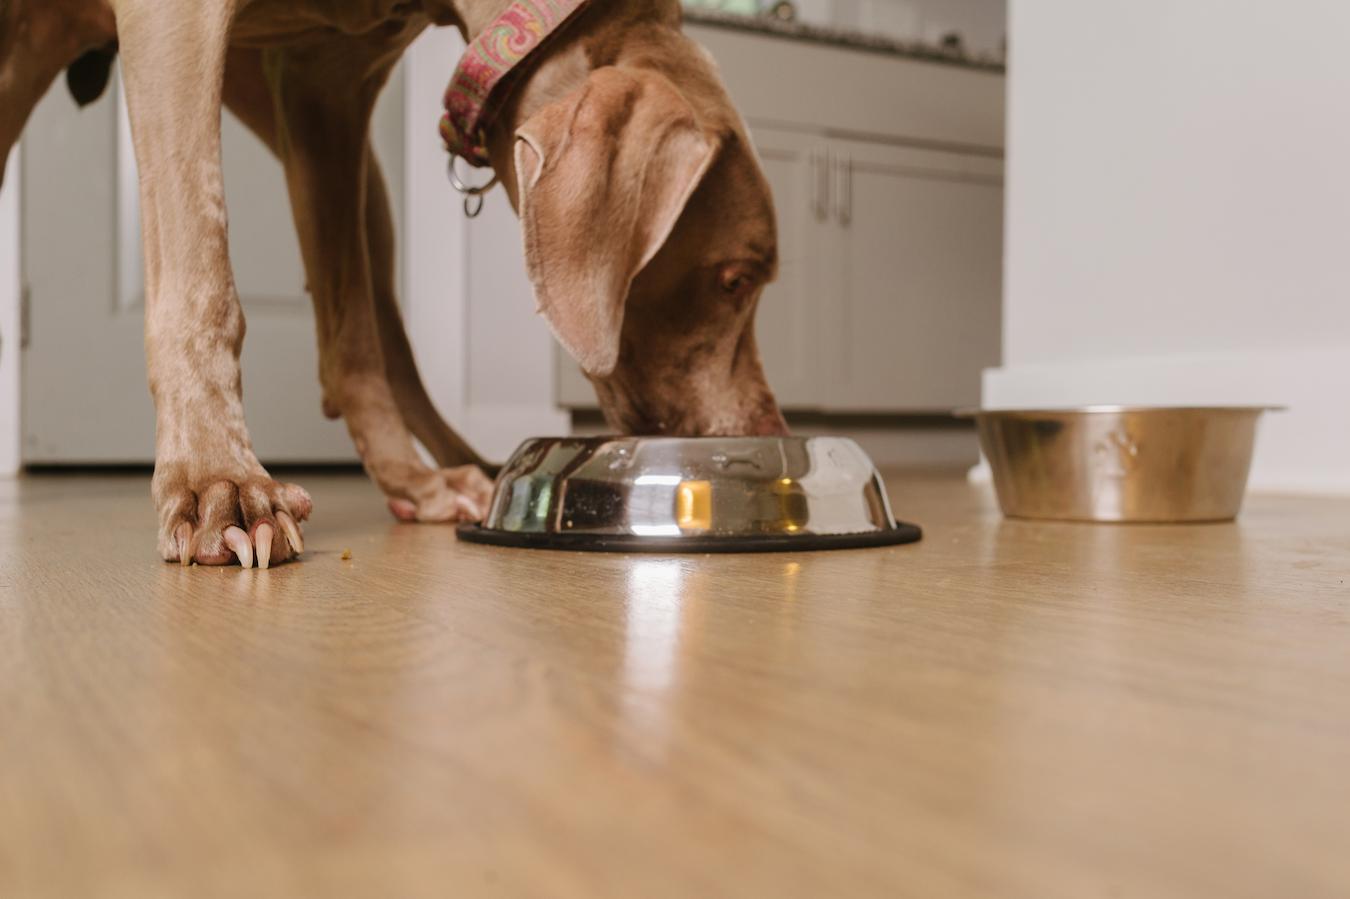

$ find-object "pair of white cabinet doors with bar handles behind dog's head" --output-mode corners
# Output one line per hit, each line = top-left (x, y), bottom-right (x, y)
(755, 128), (1003, 413)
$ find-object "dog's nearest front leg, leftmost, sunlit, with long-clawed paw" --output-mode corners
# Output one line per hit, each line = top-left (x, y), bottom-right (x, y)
(116, 0), (311, 567)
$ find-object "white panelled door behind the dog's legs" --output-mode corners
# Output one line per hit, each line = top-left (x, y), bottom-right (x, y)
(22, 67), (404, 464)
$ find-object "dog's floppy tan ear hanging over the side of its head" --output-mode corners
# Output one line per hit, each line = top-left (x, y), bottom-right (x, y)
(516, 66), (718, 377)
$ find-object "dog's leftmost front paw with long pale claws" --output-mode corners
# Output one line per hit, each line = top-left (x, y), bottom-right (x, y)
(154, 468), (313, 568)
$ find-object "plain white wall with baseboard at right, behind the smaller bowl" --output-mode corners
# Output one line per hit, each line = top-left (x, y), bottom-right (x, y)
(986, 0), (1350, 490)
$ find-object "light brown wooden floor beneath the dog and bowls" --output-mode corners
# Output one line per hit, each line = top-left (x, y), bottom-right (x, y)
(0, 475), (1350, 899)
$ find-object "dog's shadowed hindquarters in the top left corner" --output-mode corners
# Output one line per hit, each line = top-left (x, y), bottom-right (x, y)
(0, 0), (116, 178)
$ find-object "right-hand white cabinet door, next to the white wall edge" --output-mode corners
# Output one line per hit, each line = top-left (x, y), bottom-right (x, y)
(821, 140), (1003, 413)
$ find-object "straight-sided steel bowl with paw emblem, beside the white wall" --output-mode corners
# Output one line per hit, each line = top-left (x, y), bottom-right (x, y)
(959, 406), (1269, 522)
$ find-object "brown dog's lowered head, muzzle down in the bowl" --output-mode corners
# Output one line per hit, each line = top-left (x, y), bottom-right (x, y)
(510, 48), (786, 435)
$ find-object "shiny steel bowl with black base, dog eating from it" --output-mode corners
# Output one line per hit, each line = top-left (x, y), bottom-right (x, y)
(459, 437), (921, 552)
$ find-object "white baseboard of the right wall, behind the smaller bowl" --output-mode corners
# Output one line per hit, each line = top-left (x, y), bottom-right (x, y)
(972, 346), (1350, 494)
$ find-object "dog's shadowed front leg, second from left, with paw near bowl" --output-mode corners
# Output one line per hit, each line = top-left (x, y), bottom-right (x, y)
(265, 35), (491, 521)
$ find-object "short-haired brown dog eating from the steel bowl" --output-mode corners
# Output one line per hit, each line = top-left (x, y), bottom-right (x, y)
(0, 0), (786, 567)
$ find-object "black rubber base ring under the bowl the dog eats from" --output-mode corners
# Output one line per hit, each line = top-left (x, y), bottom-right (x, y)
(455, 522), (923, 555)
